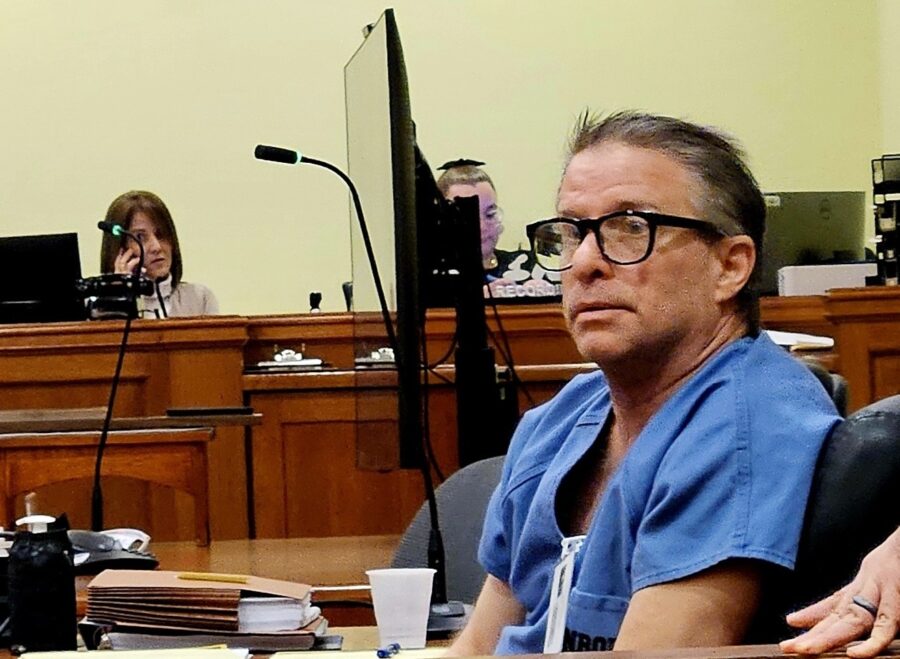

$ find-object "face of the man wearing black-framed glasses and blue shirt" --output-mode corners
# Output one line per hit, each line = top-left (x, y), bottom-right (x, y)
(557, 142), (721, 367)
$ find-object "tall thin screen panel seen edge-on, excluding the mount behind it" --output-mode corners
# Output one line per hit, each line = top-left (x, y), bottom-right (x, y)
(344, 9), (423, 467)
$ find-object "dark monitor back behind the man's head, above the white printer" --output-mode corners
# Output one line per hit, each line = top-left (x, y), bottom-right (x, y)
(759, 192), (866, 295)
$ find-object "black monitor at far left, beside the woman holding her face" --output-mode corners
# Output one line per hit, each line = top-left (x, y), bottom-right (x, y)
(0, 233), (87, 323)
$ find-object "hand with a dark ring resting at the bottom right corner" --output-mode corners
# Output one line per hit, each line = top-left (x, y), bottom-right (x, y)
(781, 528), (900, 659)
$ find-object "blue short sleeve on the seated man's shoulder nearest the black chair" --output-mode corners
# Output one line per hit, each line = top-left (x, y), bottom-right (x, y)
(626, 360), (837, 592)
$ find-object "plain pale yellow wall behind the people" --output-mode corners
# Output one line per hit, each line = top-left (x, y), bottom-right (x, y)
(0, 0), (884, 313)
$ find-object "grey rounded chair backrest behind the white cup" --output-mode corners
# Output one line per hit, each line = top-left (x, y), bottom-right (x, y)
(391, 456), (503, 604)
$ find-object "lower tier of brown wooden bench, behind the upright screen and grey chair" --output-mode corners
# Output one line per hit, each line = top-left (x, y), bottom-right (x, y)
(244, 365), (594, 538)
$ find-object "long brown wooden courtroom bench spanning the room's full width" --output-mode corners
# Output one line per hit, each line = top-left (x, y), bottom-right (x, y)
(0, 287), (900, 540)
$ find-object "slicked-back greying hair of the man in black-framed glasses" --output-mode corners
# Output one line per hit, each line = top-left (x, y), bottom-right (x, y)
(566, 110), (766, 335)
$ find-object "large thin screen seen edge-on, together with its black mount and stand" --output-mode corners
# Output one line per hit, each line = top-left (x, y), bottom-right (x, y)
(344, 9), (508, 468)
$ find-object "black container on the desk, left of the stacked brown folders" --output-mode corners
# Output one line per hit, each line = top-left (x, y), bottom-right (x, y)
(9, 523), (76, 651)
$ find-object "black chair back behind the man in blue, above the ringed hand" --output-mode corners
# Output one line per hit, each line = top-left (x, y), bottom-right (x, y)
(747, 395), (900, 642)
